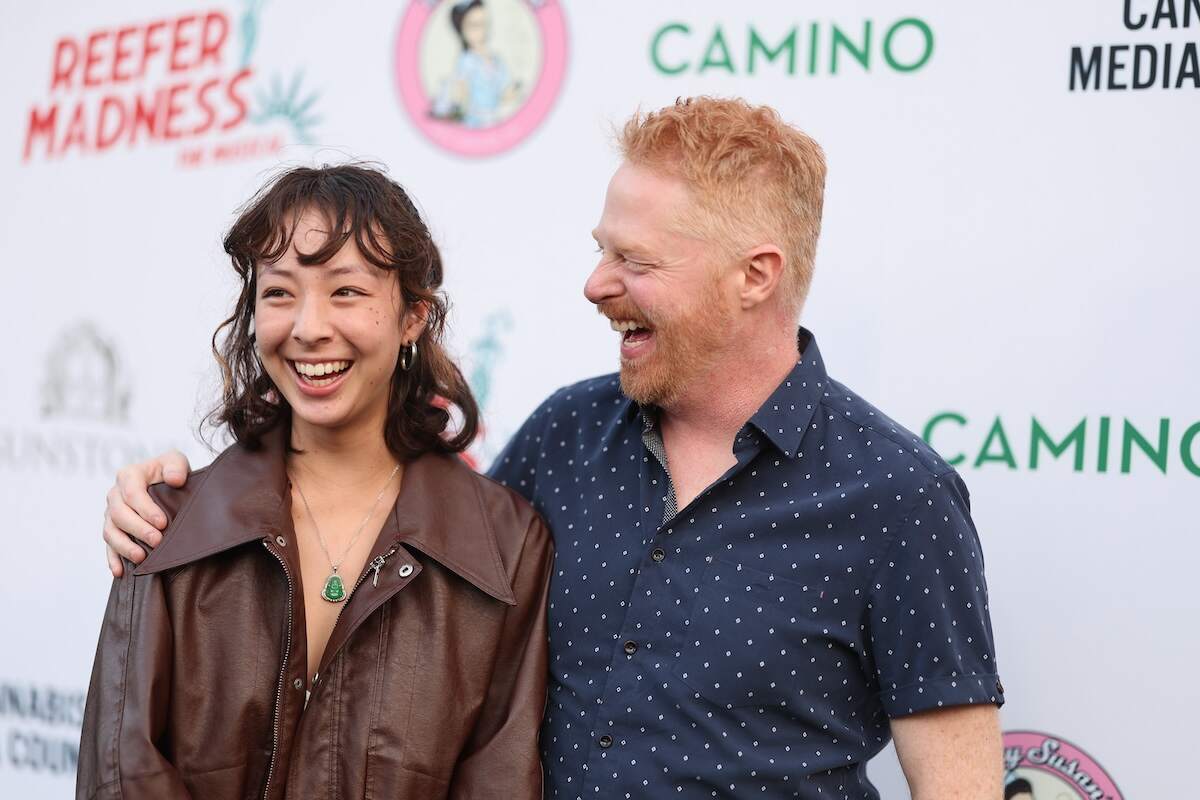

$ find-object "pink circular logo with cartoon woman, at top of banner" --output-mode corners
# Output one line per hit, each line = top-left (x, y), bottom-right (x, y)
(395, 0), (566, 156)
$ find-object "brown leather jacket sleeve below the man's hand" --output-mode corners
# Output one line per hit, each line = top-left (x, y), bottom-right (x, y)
(76, 563), (191, 800)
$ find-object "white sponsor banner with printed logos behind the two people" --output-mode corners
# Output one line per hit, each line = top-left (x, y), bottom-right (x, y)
(0, 0), (1200, 800)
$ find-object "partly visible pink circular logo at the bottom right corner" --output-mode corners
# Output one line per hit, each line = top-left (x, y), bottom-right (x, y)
(1004, 730), (1123, 800)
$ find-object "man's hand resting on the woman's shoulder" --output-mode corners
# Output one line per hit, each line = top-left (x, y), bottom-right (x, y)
(104, 450), (191, 578)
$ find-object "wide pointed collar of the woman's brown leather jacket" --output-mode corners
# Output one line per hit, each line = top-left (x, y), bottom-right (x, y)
(134, 426), (516, 604)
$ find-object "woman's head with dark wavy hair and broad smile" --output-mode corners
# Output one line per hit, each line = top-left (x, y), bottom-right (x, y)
(209, 166), (479, 459)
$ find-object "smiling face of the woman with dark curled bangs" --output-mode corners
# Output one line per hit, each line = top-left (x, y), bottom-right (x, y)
(254, 210), (424, 431)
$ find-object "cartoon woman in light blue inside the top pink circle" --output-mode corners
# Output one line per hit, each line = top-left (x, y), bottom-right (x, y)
(432, 0), (521, 128)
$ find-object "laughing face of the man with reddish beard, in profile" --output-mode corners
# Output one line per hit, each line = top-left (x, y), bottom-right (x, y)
(583, 163), (737, 408)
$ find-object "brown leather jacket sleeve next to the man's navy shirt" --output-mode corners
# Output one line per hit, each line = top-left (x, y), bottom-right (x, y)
(450, 517), (554, 800)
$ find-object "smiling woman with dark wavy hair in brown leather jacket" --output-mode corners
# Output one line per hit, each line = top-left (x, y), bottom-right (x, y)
(77, 166), (552, 800)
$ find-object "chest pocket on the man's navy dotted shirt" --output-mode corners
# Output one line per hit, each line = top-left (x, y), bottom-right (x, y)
(672, 559), (841, 709)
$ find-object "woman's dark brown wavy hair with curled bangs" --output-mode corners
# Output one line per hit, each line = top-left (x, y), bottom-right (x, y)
(205, 164), (479, 462)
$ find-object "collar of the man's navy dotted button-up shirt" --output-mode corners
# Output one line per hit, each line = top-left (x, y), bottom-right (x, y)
(624, 327), (829, 458)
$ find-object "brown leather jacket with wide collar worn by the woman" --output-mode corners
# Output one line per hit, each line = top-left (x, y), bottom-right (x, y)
(76, 434), (552, 800)
